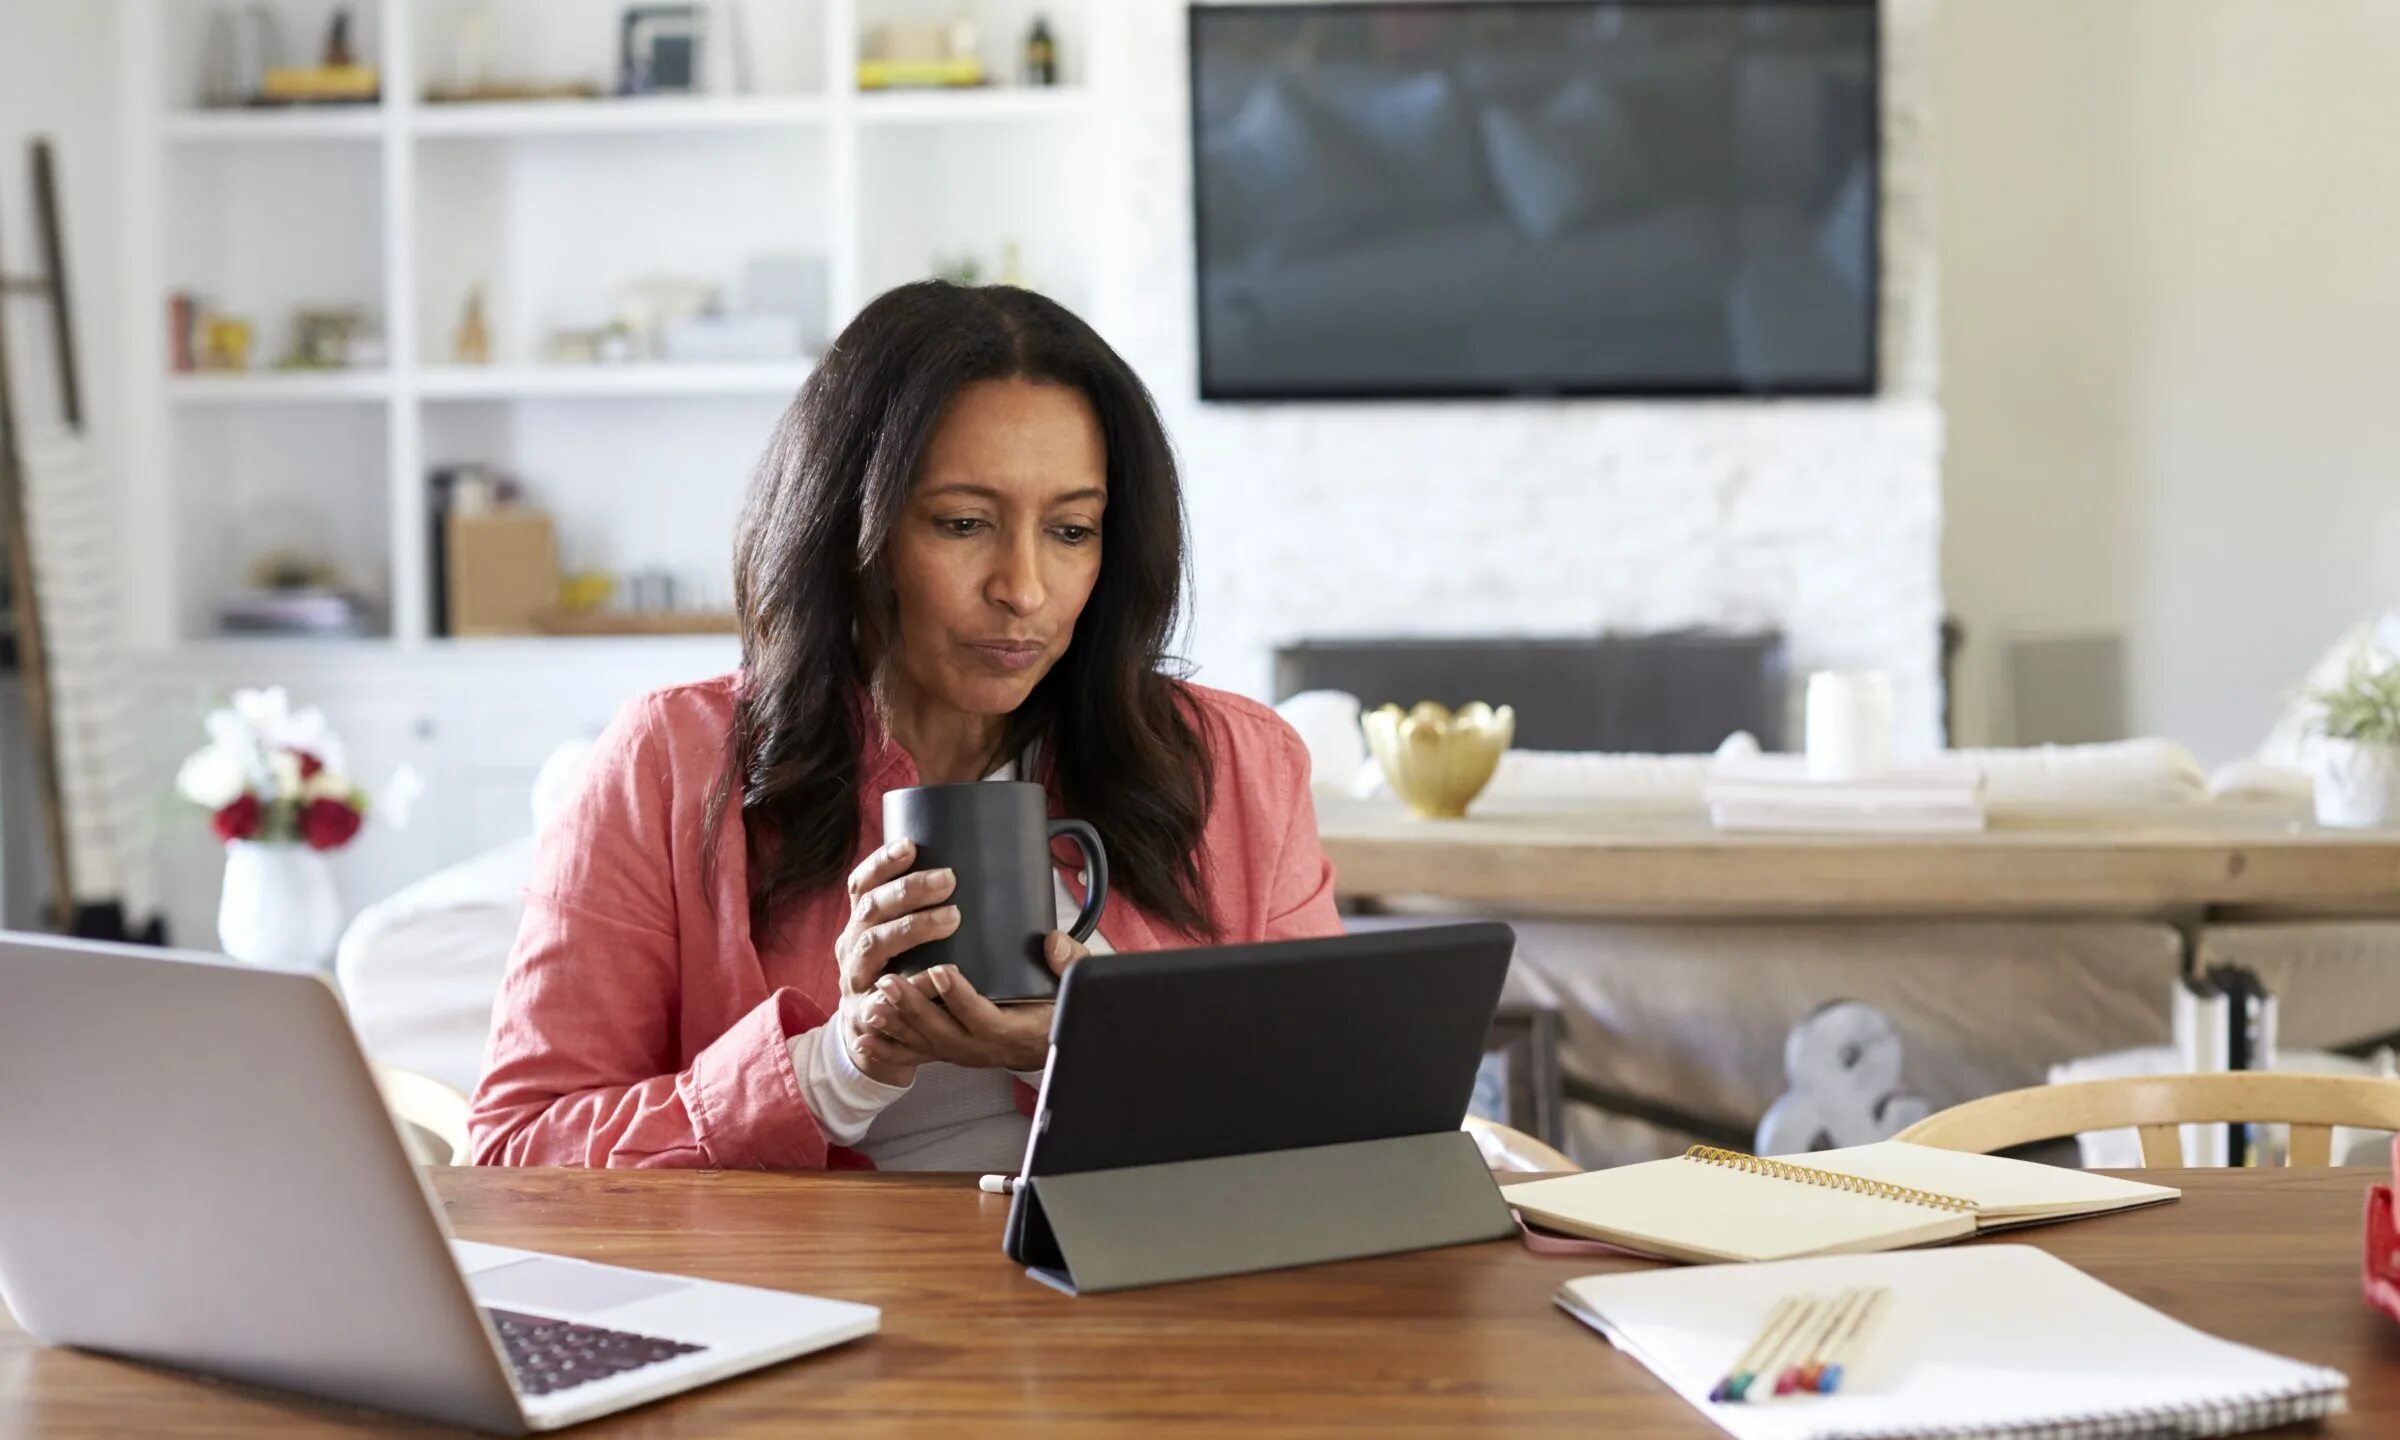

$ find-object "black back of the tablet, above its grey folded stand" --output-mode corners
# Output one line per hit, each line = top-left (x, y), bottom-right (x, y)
(1003, 922), (1517, 1265)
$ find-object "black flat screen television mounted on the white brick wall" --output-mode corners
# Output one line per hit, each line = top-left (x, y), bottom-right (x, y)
(1190, 0), (1882, 401)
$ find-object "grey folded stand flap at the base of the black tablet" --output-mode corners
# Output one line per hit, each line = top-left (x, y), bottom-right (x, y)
(1018, 1130), (1517, 1294)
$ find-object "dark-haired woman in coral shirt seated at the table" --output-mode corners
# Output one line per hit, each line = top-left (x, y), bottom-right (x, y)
(458, 283), (1339, 1169)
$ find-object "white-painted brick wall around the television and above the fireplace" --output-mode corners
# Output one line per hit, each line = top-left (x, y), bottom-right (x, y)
(1094, 0), (1942, 746)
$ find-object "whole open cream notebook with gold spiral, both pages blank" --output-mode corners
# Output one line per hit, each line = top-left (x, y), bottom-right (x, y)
(1500, 1140), (2182, 1262)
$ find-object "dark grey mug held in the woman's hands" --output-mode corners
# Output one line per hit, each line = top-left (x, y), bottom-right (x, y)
(883, 780), (1109, 1001)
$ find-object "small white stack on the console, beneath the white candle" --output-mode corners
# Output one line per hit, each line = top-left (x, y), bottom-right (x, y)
(1702, 756), (1982, 835)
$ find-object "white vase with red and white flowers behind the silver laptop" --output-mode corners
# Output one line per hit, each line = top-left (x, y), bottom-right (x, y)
(175, 689), (367, 970)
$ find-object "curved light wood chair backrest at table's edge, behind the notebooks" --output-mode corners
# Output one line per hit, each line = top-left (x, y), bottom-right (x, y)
(1894, 1070), (2400, 1166)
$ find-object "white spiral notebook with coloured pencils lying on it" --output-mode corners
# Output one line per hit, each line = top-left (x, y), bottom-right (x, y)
(1558, 1246), (2350, 1440)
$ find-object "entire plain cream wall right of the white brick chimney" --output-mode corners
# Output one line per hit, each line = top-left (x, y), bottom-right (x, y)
(1939, 0), (2400, 761)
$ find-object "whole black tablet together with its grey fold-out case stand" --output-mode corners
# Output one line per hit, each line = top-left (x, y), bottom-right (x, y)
(1003, 922), (1517, 1294)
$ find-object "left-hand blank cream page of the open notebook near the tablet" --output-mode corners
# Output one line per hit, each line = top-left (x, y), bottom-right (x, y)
(1500, 1157), (1975, 1262)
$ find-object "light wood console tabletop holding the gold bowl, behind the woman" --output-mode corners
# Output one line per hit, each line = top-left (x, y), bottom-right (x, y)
(1318, 802), (2400, 919)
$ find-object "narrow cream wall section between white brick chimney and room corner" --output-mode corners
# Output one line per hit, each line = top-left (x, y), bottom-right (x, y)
(1937, 0), (2136, 744)
